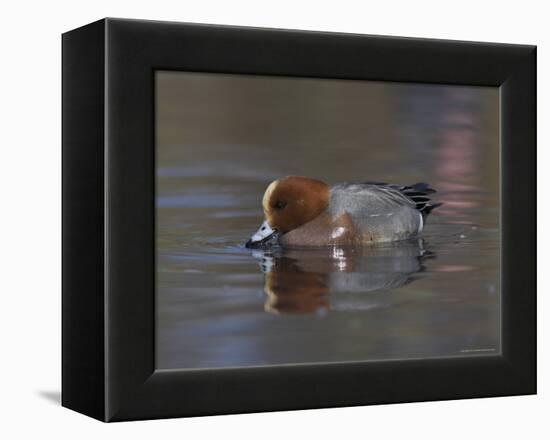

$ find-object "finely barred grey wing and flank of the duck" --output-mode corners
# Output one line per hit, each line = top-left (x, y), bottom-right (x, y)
(330, 183), (423, 241)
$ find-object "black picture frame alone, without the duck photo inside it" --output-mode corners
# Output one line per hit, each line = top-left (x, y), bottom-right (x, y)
(62, 19), (536, 421)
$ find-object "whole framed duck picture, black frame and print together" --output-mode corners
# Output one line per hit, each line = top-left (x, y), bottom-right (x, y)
(62, 19), (536, 421)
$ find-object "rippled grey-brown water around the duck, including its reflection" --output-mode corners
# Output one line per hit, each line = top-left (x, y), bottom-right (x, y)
(156, 72), (501, 369)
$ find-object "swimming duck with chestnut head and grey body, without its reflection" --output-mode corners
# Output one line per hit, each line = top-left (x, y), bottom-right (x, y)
(245, 176), (442, 248)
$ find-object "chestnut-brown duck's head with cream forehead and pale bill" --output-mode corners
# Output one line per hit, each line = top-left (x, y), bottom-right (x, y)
(246, 176), (330, 248)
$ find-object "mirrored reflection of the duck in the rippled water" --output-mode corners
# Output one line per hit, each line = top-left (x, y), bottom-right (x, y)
(253, 239), (434, 314)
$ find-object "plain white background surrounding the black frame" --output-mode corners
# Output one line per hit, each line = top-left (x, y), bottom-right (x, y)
(0, 0), (550, 440)
